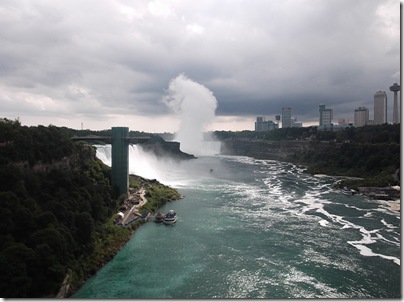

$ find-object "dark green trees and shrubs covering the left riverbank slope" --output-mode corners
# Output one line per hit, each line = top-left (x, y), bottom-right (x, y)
(0, 119), (178, 298)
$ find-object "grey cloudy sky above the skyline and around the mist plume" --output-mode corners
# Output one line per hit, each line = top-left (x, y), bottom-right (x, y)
(0, 0), (401, 132)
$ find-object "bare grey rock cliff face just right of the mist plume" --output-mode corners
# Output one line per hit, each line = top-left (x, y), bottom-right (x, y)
(220, 139), (311, 161)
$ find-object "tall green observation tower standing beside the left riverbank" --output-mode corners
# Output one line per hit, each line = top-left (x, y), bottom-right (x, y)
(111, 127), (129, 195)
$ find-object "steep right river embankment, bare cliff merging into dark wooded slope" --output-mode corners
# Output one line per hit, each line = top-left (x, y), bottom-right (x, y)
(221, 139), (400, 189)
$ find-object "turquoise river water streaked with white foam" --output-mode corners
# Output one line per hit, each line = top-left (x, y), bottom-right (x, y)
(74, 150), (401, 299)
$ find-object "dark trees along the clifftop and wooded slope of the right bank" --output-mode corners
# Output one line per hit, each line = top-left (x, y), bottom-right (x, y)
(215, 124), (401, 189)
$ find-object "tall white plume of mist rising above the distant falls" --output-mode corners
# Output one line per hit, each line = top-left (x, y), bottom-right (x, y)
(163, 74), (220, 155)
